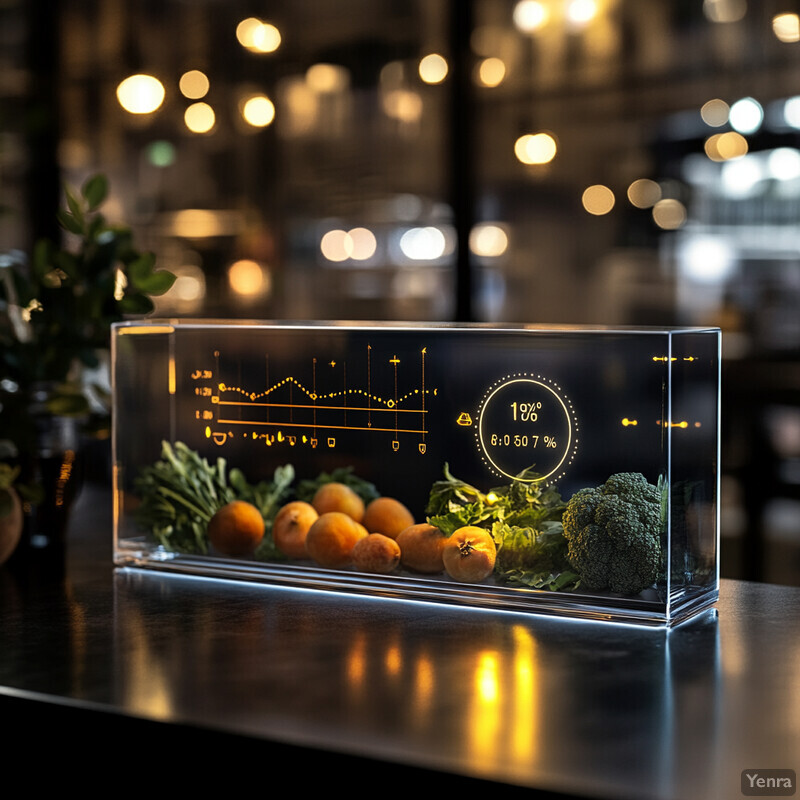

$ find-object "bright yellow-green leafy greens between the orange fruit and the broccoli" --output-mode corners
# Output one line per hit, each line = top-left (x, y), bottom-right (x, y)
(426, 464), (580, 591)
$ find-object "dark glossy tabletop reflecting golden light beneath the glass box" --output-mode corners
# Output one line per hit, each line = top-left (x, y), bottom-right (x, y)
(0, 490), (800, 800)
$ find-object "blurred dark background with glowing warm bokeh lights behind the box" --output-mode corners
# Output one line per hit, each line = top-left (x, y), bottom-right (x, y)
(0, 0), (800, 584)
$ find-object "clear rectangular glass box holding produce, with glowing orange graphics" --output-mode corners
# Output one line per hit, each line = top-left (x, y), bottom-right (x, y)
(112, 320), (721, 626)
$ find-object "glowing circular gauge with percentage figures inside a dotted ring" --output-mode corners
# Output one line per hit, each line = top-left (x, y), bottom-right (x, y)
(476, 374), (578, 483)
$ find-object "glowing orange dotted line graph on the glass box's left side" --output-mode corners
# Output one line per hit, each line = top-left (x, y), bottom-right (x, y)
(198, 344), (438, 453)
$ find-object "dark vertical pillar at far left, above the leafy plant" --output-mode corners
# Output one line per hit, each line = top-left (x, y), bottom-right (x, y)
(24, 0), (61, 248)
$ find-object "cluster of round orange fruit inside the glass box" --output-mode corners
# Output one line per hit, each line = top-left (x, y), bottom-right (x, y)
(208, 481), (497, 583)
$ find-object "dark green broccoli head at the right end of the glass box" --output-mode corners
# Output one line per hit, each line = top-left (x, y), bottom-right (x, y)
(562, 472), (661, 595)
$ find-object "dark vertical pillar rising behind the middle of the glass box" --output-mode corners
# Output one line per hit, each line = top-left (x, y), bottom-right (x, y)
(448, 0), (475, 322)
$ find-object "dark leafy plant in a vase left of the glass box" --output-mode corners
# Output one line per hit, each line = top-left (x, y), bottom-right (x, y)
(0, 175), (175, 543)
